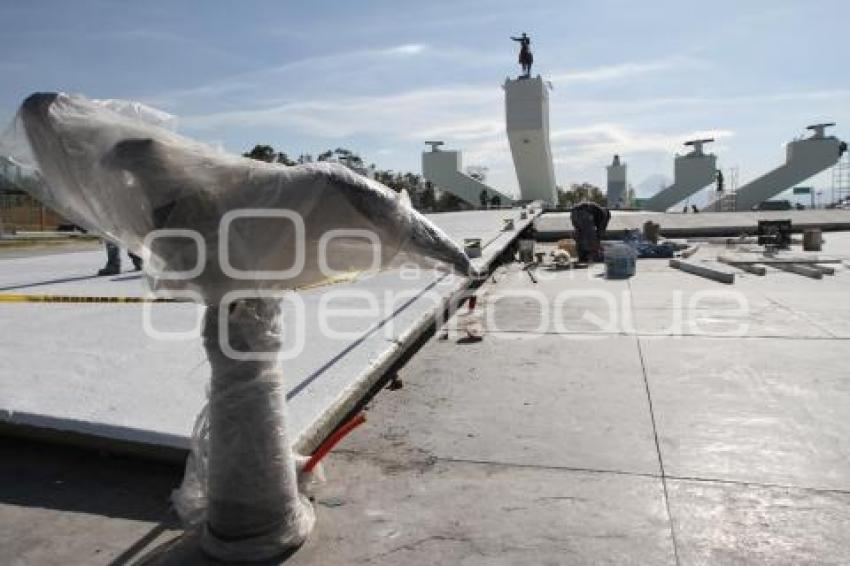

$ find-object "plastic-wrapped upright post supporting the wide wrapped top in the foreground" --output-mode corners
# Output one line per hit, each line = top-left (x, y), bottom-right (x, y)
(195, 299), (315, 561)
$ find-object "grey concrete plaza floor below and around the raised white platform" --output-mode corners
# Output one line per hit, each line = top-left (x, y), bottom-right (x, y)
(0, 229), (850, 565)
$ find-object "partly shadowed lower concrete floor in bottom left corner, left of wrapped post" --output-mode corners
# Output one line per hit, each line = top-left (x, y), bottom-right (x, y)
(0, 437), (182, 566)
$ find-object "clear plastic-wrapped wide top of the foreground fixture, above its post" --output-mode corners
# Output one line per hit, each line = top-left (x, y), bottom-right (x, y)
(0, 93), (471, 303)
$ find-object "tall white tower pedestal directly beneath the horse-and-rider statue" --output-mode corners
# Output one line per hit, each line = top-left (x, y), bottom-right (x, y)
(504, 75), (558, 205)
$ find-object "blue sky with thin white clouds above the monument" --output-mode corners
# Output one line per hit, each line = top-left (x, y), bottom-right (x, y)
(0, 0), (850, 204)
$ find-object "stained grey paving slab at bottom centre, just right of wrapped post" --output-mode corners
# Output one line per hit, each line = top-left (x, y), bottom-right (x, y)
(278, 455), (675, 566)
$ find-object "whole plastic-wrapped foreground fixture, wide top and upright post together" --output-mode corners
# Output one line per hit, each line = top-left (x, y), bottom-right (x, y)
(0, 93), (473, 560)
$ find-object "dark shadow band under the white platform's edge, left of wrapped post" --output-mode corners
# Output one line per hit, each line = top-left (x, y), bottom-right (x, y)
(0, 437), (183, 528)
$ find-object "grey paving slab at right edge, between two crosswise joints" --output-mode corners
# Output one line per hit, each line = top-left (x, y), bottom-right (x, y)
(642, 337), (850, 490)
